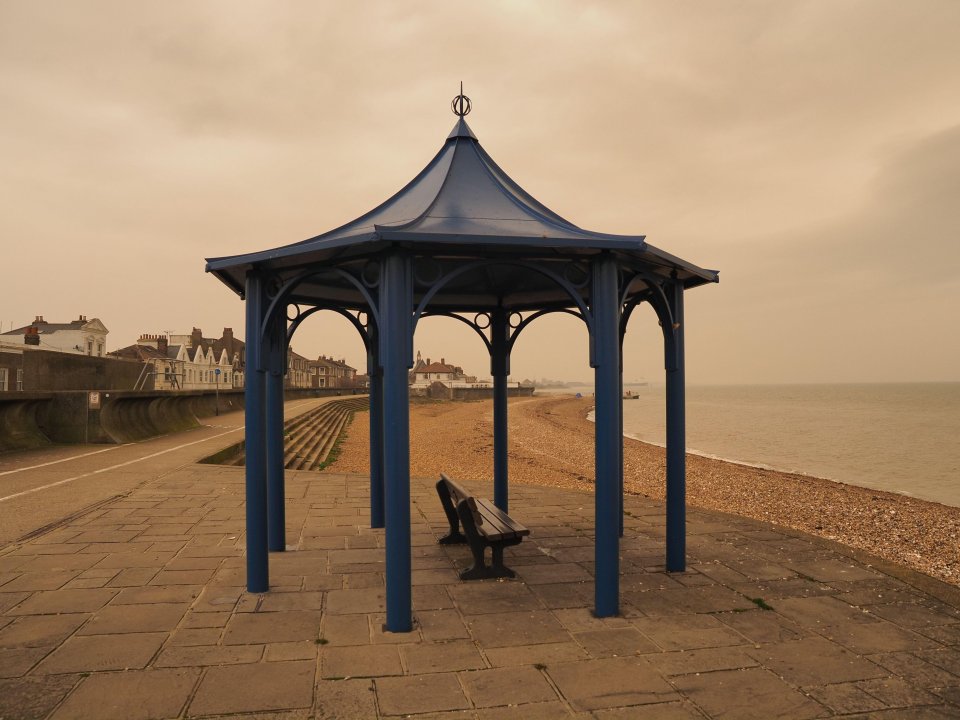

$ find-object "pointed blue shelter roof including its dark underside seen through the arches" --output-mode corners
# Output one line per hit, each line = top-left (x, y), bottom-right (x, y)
(207, 117), (718, 311)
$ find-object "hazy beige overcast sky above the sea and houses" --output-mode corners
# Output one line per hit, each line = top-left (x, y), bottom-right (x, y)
(0, 0), (960, 383)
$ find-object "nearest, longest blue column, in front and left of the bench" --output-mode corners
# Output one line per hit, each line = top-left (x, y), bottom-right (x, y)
(380, 253), (413, 632)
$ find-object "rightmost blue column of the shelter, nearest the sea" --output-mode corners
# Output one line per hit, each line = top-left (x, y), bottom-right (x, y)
(666, 281), (687, 572)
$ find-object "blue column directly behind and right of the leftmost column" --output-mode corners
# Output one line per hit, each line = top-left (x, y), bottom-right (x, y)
(266, 317), (287, 552)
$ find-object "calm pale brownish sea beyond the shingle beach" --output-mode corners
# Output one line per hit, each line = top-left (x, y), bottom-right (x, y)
(538, 383), (960, 507)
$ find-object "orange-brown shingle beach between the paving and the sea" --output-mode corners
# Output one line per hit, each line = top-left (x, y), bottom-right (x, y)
(329, 396), (960, 586)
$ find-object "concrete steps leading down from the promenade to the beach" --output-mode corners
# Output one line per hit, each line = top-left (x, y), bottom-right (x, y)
(230, 397), (370, 470)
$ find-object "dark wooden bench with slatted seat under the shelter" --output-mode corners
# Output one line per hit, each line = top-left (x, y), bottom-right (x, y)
(437, 473), (530, 580)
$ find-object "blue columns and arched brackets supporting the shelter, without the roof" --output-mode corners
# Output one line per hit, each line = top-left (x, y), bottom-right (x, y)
(238, 250), (686, 632)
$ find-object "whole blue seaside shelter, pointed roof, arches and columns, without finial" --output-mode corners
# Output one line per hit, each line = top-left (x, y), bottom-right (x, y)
(221, 111), (718, 632)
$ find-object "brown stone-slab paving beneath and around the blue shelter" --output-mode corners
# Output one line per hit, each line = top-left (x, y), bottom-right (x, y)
(0, 428), (960, 720)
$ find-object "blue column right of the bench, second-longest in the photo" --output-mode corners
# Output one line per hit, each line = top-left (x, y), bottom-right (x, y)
(590, 253), (622, 617)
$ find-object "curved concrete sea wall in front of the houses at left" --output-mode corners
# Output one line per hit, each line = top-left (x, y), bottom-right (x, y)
(0, 388), (365, 452)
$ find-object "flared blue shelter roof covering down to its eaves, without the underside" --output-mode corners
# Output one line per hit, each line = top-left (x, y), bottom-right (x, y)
(207, 117), (717, 304)
